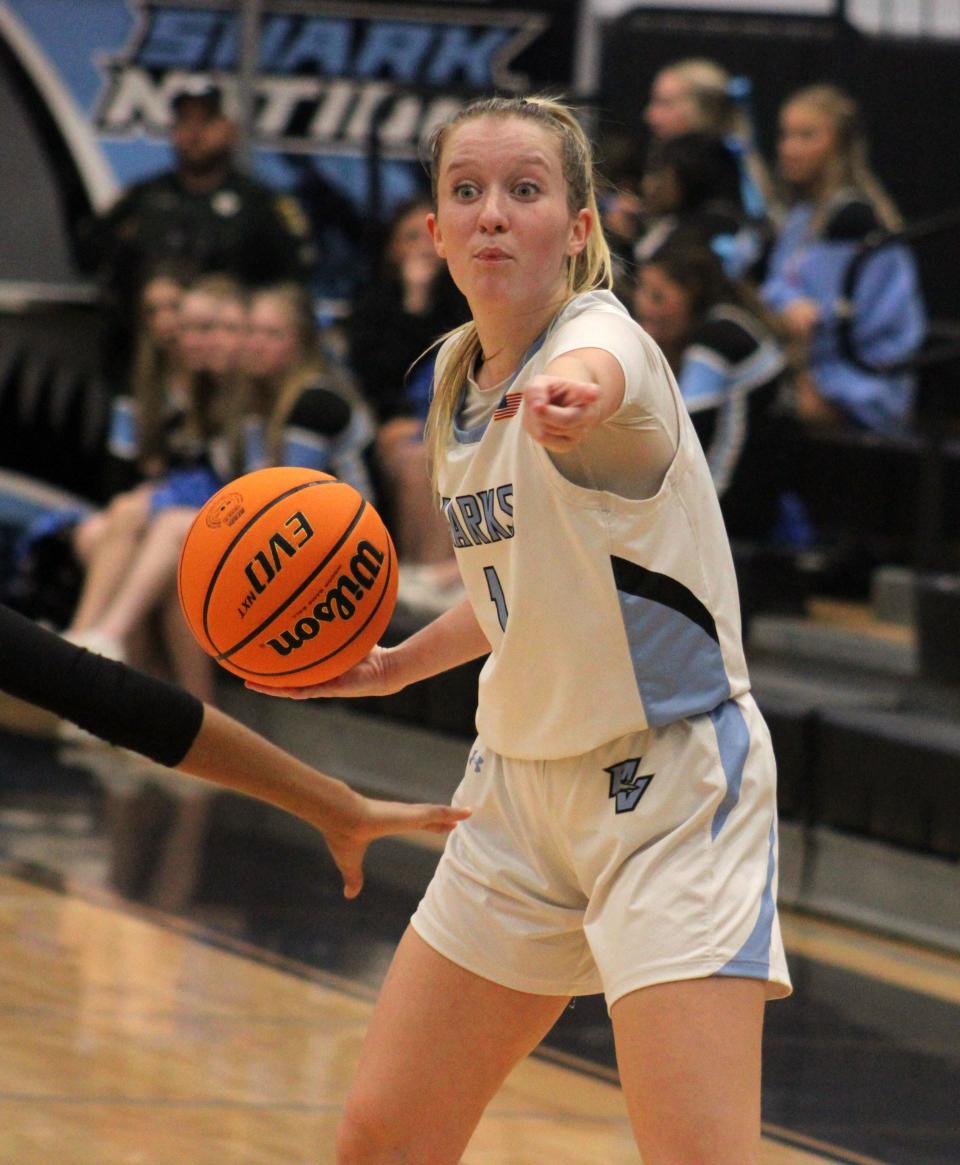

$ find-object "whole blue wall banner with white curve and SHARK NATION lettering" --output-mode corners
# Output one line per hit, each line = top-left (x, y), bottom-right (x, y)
(0, 0), (578, 295)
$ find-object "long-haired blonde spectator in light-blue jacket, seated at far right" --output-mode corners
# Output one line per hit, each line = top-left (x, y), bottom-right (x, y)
(762, 85), (925, 433)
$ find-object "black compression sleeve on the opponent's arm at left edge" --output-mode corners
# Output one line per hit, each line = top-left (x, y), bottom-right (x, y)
(0, 606), (204, 768)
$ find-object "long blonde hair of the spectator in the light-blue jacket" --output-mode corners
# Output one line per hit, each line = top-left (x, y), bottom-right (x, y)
(783, 84), (903, 233)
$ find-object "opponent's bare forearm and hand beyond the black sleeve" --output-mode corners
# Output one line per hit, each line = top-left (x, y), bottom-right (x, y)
(176, 705), (471, 898)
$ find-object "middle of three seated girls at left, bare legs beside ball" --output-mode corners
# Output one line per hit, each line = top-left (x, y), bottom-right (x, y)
(60, 275), (246, 701)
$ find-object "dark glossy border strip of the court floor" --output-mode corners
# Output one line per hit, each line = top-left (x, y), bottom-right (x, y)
(0, 733), (960, 1165)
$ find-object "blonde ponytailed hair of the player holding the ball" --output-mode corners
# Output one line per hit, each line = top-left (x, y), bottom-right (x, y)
(424, 97), (613, 485)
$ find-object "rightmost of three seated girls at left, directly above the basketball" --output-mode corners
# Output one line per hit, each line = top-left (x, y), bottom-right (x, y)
(238, 283), (374, 499)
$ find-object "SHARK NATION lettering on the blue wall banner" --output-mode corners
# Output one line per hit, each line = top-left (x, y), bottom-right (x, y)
(93, 0), (573, 160)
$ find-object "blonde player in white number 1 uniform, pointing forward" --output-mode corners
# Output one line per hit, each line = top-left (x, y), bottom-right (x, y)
(251, 98), (790, 1165)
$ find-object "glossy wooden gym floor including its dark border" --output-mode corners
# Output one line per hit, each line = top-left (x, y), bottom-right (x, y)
(0, 733), (960, 1165)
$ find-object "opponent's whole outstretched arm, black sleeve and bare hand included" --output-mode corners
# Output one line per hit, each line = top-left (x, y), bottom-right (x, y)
(0, 605), (465, 898)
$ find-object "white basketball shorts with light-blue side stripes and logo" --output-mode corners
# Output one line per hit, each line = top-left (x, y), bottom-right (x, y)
(412, 694), (791, 1008)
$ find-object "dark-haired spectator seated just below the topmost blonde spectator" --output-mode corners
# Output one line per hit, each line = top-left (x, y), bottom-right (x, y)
(634, 133), (767, 277)
